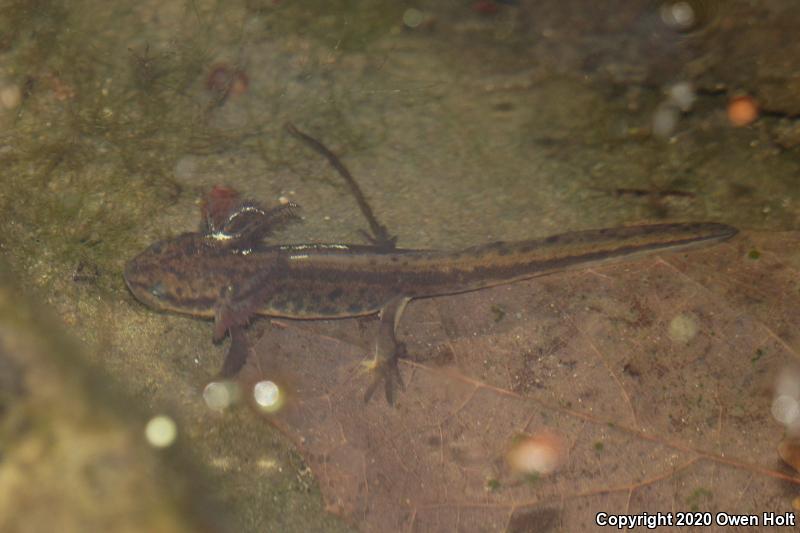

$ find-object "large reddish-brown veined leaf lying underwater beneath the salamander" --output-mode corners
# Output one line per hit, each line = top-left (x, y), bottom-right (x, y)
(242, 233), (800, 531)
